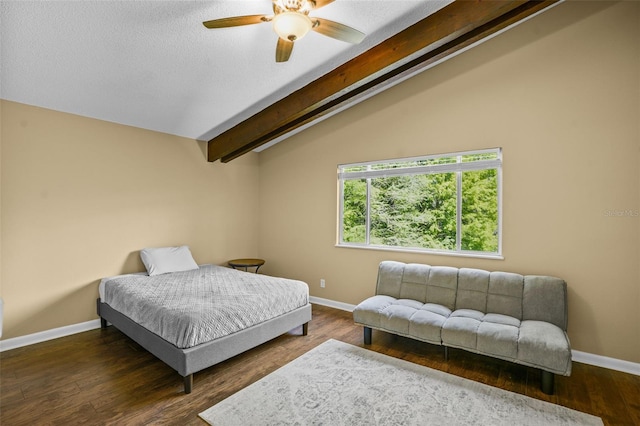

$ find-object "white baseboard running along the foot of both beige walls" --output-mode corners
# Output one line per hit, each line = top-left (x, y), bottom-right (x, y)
(0, 302), (640, 376)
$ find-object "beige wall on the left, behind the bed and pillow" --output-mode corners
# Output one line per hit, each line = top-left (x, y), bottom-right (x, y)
(0, 101), (258, 338)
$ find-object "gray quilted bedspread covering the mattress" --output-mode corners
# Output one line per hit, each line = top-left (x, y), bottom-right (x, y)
(102, 265), (309, 348)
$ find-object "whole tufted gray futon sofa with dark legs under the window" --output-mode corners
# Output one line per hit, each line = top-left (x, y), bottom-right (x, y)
(353, 261), (571, 394)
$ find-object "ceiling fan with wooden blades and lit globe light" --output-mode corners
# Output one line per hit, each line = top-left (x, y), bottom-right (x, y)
(203, 0), (365, 62)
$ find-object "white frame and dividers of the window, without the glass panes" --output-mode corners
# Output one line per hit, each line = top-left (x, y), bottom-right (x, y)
(336, 148), (503, 259)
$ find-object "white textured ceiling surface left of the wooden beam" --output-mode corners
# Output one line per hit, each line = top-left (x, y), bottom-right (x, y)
(0, 0), (451, 140)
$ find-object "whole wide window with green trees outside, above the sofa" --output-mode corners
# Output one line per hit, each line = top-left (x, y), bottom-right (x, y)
(338, 149), (502, 256)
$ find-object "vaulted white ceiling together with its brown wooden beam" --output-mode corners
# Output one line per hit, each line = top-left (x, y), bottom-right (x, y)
(0, 0), (557, 161)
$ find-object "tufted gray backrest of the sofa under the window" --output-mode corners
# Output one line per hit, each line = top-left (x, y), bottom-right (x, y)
(376, 261), (567, 330)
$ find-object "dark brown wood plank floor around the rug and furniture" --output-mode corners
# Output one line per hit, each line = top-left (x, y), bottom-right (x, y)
(0, 305), (640, 426)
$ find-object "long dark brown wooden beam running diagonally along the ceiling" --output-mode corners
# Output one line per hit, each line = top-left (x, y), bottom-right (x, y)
(208, 0), (559, 162)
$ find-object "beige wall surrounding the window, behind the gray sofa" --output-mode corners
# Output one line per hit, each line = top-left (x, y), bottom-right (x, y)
(259, 2), (640, 362)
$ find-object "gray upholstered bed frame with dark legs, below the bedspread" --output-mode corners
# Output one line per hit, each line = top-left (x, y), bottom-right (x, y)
(97, 298), (311, 393)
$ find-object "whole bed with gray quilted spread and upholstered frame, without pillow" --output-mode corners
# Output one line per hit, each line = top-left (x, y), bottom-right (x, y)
(97, 248), (311, 394)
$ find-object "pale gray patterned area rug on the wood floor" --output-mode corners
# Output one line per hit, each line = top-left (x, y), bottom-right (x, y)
(200, 340), (603, 426)
